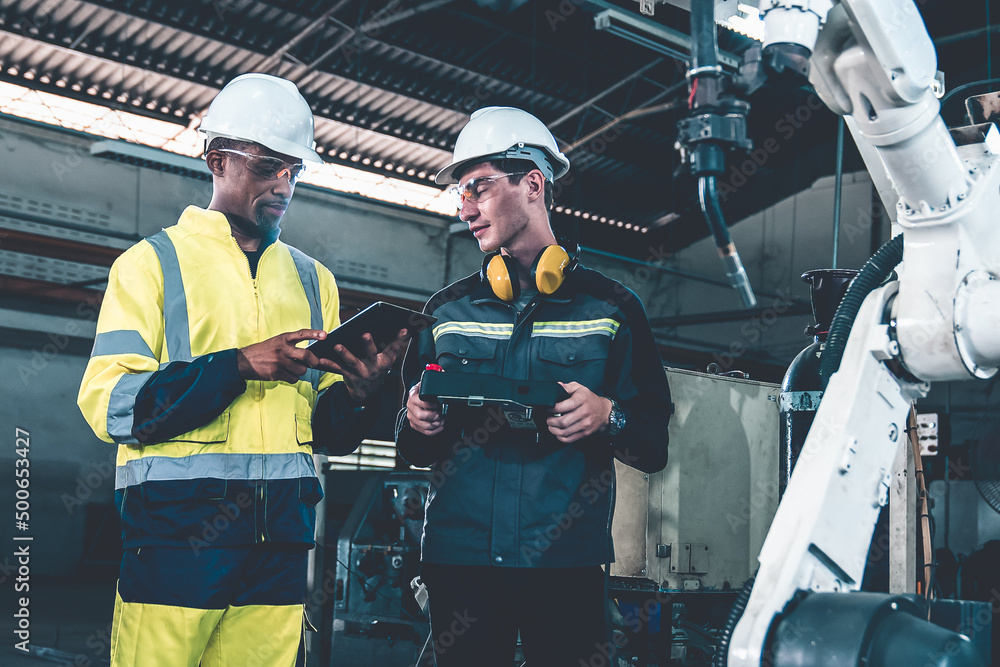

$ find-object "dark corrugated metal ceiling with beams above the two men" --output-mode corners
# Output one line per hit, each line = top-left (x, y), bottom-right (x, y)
(0, 0), (988, 257)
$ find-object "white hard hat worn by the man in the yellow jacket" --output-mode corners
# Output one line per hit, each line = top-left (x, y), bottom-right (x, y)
(198, 73), (323, 164)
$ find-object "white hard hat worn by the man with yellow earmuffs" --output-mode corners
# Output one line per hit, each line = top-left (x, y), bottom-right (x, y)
(434, 107), (569, 185)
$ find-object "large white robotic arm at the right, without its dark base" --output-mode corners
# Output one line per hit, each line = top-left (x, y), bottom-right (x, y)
(728, 0), (1000, 667)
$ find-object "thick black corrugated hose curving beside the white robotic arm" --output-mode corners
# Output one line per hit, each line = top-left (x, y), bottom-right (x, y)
(819, 234), (903, 389)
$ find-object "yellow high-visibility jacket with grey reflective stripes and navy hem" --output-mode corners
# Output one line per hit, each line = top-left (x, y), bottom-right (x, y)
(78, 206), (341, 548)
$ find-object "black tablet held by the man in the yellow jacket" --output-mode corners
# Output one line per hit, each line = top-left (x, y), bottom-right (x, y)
(309, 301), (437, 361)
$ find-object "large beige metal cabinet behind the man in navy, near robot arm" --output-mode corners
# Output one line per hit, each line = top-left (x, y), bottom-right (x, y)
(611, 368), (781, 591)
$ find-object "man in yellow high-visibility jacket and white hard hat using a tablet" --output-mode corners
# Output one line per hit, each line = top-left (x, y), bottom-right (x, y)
(78, 74), (405, 667)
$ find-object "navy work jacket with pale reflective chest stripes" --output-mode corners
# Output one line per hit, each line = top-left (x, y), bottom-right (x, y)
(396, 267), (671, 567)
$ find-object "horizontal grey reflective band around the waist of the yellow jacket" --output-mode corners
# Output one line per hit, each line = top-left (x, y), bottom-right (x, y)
(115, 452), (316, 489)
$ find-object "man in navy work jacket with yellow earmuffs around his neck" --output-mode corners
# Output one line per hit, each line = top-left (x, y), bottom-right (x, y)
(397, 107), (670, 667)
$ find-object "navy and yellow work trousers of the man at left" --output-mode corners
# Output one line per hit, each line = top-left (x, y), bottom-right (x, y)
(111, 545), (308, 667)
